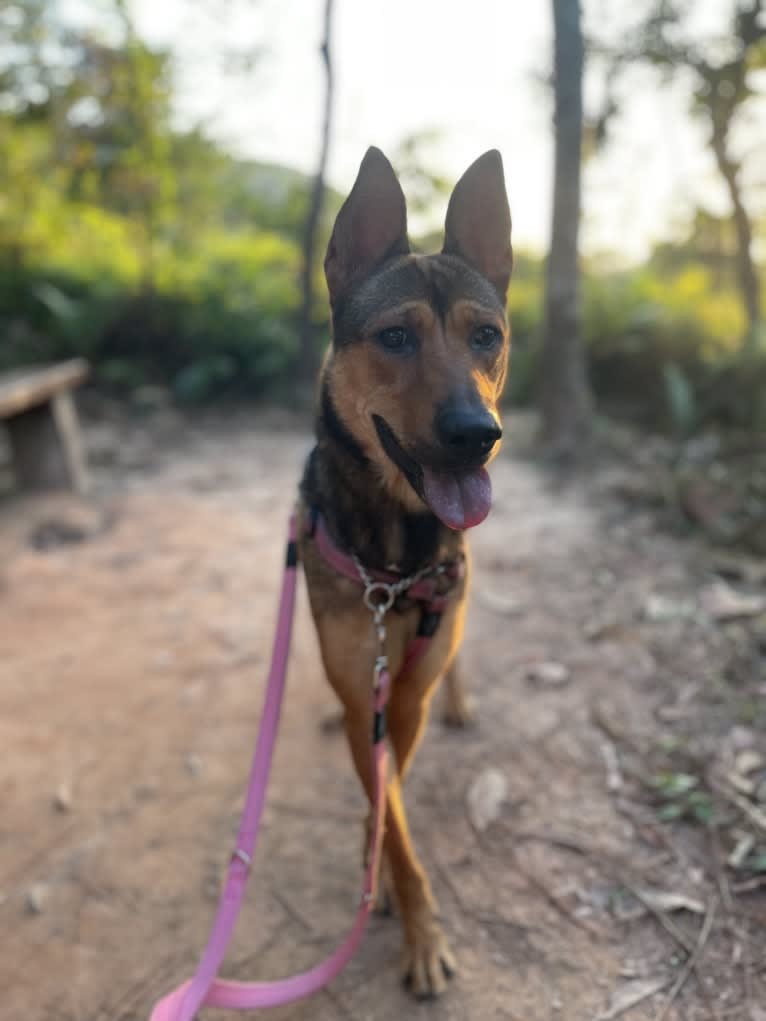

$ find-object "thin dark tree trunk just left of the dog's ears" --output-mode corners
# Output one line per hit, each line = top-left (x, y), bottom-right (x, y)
(298, 0), (334, 382)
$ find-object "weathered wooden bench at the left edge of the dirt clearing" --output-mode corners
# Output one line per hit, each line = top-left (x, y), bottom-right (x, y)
(0, 358), (89, 492)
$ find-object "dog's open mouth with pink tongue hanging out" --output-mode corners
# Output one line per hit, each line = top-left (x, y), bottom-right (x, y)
(373, 415), (492, 530)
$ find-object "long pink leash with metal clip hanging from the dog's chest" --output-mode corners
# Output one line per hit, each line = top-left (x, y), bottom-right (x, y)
(150, 516), (393, 1021)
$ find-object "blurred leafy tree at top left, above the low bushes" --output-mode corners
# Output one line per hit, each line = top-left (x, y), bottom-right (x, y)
(0, 0), (177, 290)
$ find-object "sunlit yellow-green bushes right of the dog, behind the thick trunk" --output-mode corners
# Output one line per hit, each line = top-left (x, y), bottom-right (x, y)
(507, 253), (766, 434)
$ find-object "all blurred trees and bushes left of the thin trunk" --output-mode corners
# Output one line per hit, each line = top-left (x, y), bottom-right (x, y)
(0, 0), (318, 400)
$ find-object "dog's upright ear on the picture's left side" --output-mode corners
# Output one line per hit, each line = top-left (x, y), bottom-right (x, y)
(325, 146), (410, 304)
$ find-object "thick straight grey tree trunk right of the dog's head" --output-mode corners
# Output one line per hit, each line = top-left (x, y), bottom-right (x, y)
(540, 0), (591, 459)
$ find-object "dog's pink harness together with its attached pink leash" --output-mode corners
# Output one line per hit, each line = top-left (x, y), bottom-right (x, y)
(150, 515), (463, 1021)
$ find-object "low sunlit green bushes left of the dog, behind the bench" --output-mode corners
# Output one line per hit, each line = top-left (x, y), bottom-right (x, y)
(0, 214), (306, 400)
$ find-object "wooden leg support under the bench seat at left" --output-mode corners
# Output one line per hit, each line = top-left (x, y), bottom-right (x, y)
(6, 391), (88, 492)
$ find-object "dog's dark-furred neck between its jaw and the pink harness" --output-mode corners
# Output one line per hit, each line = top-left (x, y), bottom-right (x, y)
(302, 390), (463, 575)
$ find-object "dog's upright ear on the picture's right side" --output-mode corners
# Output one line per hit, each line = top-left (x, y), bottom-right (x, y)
(442, 149), (513, 301)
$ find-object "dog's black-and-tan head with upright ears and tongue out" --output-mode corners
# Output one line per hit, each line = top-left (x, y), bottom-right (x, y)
(323, 148), (512, 529)
